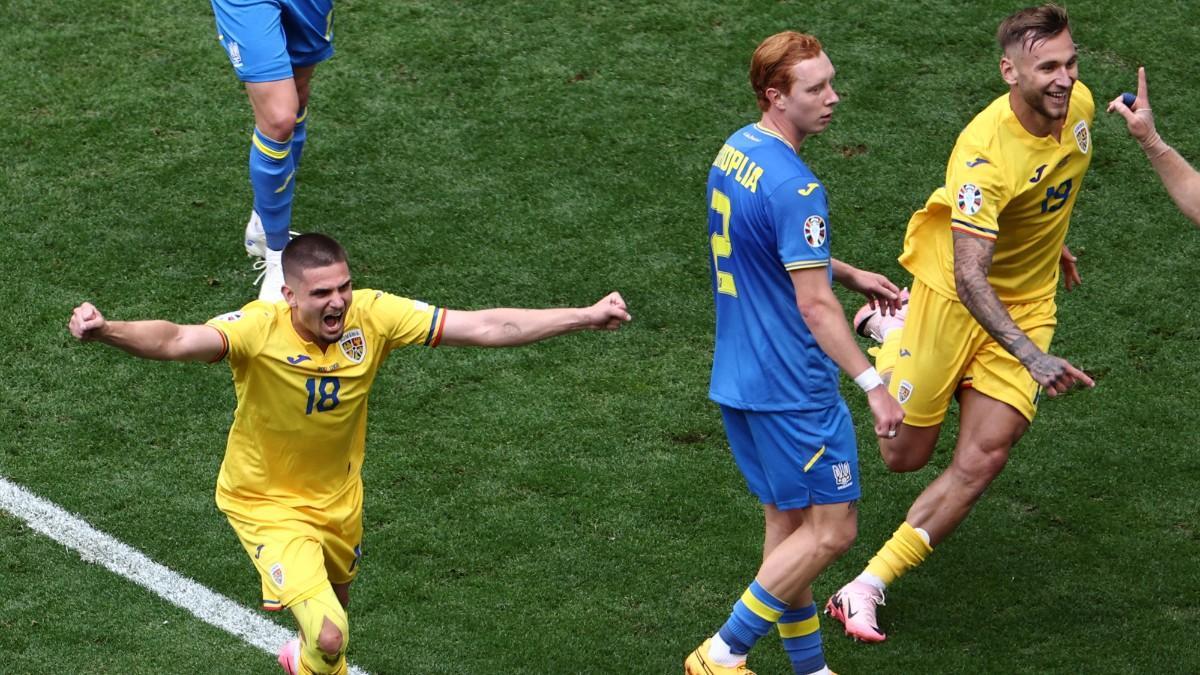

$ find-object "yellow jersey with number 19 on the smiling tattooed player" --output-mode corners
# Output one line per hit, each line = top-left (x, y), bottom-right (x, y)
(900, 82), (1096, 304)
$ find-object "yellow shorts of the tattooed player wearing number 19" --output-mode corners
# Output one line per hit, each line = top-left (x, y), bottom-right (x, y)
(888, 280), (1057, 426)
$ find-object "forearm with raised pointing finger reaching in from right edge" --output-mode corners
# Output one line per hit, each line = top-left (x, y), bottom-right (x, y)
(1108, 67), (1200, 225)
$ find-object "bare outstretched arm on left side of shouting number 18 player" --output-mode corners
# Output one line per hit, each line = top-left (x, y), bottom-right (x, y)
(67, 303), (226, 362)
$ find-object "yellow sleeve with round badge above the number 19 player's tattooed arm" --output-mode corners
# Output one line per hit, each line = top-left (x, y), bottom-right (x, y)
(946, 147), (1012, 240)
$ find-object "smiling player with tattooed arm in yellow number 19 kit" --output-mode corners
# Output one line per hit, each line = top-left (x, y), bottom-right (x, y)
(826, 5), (1094, 641)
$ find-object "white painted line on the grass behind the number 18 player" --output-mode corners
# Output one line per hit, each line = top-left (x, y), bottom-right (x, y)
(0, 476), (367, 675)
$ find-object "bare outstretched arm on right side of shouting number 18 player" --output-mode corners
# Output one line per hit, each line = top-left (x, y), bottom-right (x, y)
(442, 292), (631, 347)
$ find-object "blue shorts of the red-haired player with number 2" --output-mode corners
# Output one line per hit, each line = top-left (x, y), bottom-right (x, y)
(721, 400), (862, 510)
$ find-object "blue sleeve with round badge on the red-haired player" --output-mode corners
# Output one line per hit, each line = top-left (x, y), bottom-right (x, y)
(768, 178), (830, 271)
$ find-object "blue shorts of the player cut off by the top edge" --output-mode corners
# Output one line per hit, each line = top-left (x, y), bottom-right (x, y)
(212, 0), (334, 82)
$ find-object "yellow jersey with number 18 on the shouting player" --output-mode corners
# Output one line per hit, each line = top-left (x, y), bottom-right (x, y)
(208, 285), (445, 519)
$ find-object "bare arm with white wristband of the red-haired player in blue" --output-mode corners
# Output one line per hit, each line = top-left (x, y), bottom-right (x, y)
(790, 267), (904, 438)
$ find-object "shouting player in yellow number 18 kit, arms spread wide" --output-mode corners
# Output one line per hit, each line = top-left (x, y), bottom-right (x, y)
(70, 234), (630, 675)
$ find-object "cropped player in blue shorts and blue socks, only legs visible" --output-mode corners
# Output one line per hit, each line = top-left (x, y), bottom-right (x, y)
(212, 0), (334, 303)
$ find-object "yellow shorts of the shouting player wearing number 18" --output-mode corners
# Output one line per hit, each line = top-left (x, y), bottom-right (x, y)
(223, 494), (362, 611)
